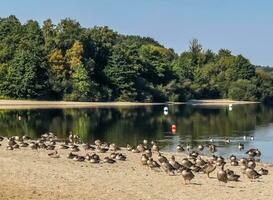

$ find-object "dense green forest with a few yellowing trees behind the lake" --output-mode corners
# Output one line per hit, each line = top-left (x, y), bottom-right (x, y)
(0, 16), (273, 102)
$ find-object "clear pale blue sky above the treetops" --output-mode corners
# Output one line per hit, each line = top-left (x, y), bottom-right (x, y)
(0, 0), (273, 66)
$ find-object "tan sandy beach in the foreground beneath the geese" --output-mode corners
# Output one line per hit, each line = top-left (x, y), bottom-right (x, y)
(0, 141), (273, 200)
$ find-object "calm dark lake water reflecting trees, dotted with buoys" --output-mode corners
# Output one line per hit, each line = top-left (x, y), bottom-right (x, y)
(0, 104), (273, 163)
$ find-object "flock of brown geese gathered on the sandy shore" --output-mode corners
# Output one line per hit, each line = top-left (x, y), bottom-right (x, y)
(0, 133), (268, 184)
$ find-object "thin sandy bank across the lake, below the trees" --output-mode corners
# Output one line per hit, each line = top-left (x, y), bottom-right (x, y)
(0, 99), (258, 109)
